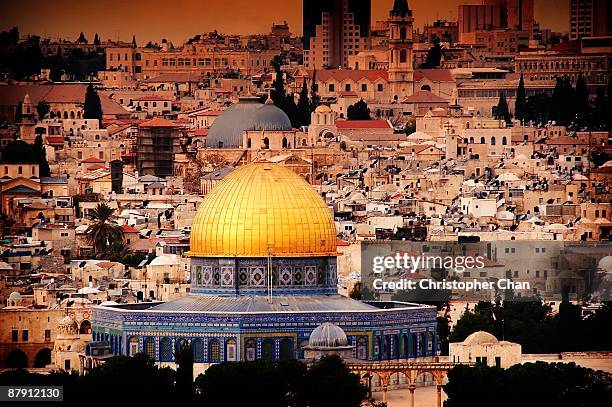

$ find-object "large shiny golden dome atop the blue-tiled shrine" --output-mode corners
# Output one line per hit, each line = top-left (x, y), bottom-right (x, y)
(187, 163), (336, 257)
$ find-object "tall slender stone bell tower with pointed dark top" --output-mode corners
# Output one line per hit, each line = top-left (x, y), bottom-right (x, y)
(387, 0), (414, 102)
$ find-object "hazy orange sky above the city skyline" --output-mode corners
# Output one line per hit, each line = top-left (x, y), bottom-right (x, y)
(0, 0), (569, 44)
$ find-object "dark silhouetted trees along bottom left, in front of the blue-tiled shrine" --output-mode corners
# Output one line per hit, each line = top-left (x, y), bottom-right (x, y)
(0, 356), (367, 407)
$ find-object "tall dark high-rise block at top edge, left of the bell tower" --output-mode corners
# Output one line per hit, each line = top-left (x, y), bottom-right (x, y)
(302, 0), (371, 69)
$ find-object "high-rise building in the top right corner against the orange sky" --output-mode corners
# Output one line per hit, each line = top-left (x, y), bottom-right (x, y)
(569, 0), (612, 40)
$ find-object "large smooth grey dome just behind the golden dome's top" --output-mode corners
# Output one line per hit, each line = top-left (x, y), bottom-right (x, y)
(206, 96), (291, 148)
